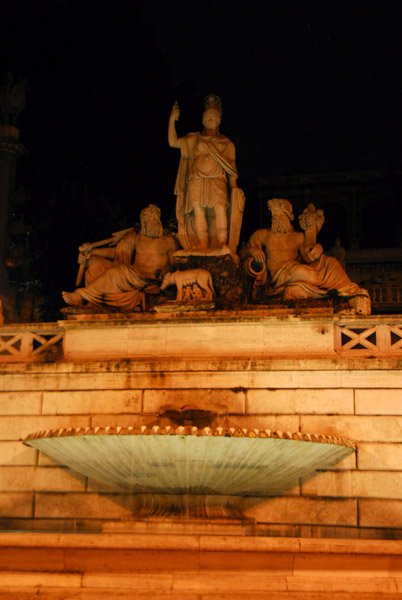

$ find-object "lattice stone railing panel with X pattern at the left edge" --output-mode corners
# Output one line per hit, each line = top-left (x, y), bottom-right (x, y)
(0, 324), (64, 362)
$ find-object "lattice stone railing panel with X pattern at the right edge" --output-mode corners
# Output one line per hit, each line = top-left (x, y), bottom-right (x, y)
(335, 322), (402, 355)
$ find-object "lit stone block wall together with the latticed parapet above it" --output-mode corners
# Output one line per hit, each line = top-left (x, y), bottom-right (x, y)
(0, 311), (402, 539)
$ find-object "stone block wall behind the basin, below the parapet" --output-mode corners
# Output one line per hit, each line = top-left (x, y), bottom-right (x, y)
(0, 316), (402, 539)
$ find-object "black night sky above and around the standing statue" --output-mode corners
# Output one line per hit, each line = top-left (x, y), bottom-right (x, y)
(0, 0), (402, 304)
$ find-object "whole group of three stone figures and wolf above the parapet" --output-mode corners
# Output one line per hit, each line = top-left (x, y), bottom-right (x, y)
(63, 95), (371, 314)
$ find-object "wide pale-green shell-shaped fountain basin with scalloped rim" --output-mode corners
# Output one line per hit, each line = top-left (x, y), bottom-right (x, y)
(24, 426), (356, 497)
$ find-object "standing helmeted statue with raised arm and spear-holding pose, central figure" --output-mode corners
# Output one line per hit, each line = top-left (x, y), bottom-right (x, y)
(168, 95), (244, 253)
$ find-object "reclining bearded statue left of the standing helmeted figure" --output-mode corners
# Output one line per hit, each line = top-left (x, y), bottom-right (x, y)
(62, 204), (177, 310)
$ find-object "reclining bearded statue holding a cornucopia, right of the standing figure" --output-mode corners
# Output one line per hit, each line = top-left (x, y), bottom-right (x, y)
(240, 198), (371, 314)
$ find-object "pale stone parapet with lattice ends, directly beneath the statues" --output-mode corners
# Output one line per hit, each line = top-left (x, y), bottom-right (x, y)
(0, 311), (402, 363)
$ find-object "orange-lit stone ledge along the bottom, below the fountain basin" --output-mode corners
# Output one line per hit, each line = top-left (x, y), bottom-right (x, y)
(0, 532), (402, 600)
